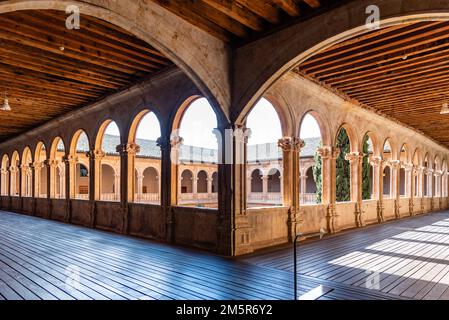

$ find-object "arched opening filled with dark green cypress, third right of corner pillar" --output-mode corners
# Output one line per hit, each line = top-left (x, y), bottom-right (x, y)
(336, 128), (351, 202)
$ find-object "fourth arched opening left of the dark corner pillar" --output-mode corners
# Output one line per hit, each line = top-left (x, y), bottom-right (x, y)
(70, 130), (90, 200)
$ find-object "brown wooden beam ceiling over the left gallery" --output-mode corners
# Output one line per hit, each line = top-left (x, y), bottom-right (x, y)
(0, 10), (172, 141)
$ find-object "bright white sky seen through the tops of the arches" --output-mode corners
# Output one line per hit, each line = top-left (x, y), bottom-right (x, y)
(106, 98), (321, 149)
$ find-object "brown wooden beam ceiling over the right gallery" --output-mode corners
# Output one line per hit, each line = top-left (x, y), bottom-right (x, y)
(296, 22), (449, 147)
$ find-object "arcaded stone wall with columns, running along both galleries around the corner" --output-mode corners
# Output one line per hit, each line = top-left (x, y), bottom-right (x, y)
(0, 69), (448, 255)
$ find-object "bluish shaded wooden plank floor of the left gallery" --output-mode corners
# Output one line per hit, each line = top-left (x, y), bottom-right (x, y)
(0, 211), (395, 300)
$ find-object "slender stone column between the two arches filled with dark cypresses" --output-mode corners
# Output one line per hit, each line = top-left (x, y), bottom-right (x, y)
(345, 152), (365, 227)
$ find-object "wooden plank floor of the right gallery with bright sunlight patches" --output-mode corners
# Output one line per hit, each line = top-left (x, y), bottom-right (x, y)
(243, 212), (449, 300)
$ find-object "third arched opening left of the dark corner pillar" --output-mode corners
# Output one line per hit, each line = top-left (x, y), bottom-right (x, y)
(95, 120), (121, 201)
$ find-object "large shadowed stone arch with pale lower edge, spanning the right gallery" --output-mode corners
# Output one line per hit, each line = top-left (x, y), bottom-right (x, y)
(231, 0), (449, 123)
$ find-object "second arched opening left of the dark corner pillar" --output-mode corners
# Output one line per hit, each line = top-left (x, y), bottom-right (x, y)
(128, 110), (161, 205)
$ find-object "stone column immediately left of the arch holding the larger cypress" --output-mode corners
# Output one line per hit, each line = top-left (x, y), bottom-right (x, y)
(318, 147), (340, 233)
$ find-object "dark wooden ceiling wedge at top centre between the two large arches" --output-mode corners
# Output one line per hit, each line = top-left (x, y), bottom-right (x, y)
(152, 0), (336, 43)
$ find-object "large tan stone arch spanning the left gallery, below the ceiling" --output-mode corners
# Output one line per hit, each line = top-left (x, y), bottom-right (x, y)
(0, 0), (231, 119)
